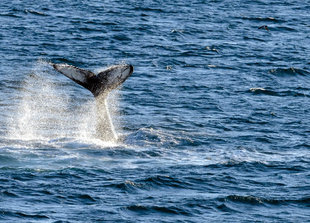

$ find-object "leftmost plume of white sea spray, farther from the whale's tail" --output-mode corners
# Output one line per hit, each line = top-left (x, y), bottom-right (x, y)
(9, 61), (69, 140)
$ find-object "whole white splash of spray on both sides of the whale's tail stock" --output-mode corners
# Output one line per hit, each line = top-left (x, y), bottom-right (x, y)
(8, 61), (120, 144)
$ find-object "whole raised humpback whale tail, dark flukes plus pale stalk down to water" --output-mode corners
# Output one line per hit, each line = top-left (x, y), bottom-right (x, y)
(50, 63), (133, 141)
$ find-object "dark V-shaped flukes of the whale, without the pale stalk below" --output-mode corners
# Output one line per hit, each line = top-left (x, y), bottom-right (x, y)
(50, 63), (133, 97)
